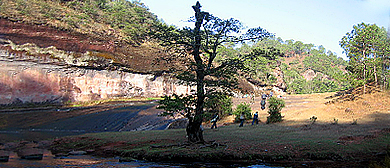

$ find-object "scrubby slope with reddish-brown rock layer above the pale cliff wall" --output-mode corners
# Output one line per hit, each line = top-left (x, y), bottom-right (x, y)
(0, 0), (171, 73)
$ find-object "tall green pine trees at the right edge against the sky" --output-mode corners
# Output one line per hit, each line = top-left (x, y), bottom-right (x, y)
(340, 23), (389, 90)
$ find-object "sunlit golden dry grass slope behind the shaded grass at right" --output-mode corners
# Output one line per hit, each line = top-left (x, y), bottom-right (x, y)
(225, 86), (390, 125)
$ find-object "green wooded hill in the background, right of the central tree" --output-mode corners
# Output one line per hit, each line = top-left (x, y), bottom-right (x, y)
(230, 37), (351, 94)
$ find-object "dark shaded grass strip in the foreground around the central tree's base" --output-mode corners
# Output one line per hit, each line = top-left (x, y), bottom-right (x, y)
(53, 121), (390, 167)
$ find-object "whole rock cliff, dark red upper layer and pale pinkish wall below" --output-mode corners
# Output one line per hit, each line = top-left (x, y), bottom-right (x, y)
(0, 17), (191, 104)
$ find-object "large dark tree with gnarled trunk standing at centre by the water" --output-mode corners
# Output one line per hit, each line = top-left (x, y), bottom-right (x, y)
(153, 2), (272, 142)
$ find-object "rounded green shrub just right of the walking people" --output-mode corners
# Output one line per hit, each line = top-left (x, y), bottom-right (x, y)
(266, 97), (285, 124)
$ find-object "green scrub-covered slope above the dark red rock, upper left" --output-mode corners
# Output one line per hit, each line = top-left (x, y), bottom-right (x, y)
(0, 0), (158, 44)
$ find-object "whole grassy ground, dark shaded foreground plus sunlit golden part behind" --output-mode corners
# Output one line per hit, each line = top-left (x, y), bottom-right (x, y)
(52, 92), (390, 167)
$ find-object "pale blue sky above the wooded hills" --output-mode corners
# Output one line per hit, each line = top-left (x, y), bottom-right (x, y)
(140, 0), (390, 59)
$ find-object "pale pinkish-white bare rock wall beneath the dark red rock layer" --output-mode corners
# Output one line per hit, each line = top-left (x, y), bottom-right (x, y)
(0, 50), (190, 104)
